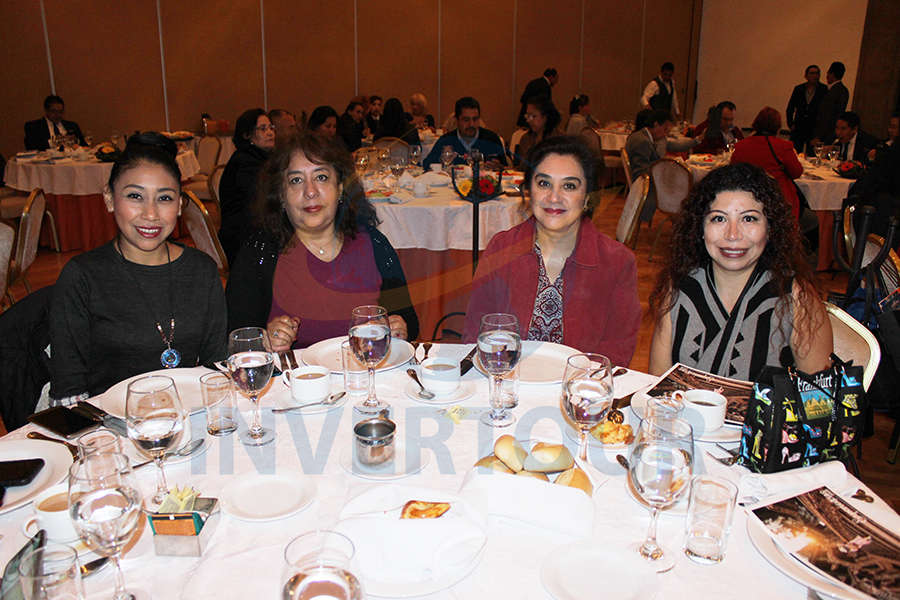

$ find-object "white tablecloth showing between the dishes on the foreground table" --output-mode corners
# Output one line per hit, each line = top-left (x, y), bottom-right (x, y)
(0, 345), (900, 600)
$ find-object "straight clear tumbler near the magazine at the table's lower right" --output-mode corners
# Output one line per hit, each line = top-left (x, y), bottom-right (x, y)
(684, 475), (737, 564)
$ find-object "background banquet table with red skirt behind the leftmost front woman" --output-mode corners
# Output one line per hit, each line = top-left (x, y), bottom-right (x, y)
(4, 150), (200, 252)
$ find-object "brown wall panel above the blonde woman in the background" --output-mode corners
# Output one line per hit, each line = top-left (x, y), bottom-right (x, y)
(356, 0), (439, 118)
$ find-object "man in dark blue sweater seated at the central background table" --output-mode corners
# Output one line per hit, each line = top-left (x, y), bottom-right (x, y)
(422, 96), (507, 171)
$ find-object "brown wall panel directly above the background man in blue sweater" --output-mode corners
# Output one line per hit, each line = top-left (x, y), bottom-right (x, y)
(435, 0), (518, 139)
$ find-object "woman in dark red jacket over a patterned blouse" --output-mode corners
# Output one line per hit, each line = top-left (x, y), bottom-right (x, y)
(464, 137), (641, 366)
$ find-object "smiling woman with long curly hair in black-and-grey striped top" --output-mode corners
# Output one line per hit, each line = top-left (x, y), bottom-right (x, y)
(650, 163), (832, 380)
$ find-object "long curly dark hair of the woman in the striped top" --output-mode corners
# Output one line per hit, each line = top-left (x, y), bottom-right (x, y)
(650, 163), (820, 354)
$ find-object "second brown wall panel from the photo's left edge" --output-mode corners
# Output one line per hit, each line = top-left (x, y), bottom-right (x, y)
(44, 0), (165, 139)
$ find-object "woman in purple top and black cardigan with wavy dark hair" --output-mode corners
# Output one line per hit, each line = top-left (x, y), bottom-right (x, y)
(226, 133), (419, 352)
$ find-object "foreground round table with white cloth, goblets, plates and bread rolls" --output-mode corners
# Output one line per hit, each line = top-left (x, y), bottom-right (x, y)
(0, 307), (900, 600)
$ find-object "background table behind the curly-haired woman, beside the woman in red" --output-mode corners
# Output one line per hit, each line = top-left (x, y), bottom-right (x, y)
(688, 154), (854, 271)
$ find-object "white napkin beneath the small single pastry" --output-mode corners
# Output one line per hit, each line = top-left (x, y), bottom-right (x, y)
(335, 486), (487, 587)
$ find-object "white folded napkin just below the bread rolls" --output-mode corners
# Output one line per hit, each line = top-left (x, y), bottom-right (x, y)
(460, 469), (594, 536)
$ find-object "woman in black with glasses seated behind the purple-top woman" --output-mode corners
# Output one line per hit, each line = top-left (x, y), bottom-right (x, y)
(219, 108), (275, 264)
